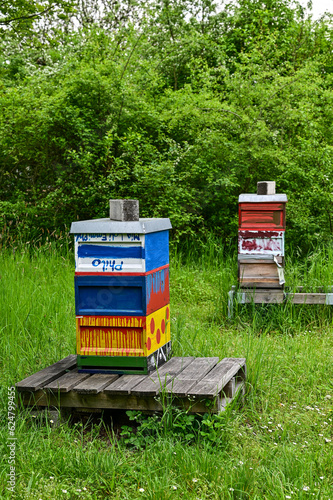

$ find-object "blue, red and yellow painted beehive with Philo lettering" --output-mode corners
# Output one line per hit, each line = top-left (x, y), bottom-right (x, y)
(71, 200), (171, 374)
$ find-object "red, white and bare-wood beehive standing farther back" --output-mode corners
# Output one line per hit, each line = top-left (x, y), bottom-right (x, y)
(238, 182), (287, 288)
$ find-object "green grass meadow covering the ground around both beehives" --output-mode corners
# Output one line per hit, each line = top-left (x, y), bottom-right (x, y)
(0, 241), (333, 500)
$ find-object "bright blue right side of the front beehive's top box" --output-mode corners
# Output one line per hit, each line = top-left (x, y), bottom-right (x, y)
(145, 231), (169, 272)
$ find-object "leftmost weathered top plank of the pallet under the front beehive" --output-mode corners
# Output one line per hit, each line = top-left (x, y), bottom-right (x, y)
(16, 354), (76, 392)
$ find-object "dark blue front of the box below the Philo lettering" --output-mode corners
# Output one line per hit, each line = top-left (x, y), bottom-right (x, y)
(75, 276), (146, 316)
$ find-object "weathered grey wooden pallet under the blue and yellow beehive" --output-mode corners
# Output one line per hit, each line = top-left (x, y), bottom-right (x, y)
(16, 355), (246, 413)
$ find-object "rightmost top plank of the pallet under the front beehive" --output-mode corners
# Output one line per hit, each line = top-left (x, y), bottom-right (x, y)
(188, 358), (245, 399)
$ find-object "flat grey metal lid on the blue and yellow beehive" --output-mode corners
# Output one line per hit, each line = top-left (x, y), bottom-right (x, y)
(70, 218), (172, 234)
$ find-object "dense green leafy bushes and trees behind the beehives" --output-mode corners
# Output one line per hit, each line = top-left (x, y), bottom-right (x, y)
(0, 0), (333, 248)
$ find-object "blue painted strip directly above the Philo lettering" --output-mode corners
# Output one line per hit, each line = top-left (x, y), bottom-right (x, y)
(78, 244), (145, 259)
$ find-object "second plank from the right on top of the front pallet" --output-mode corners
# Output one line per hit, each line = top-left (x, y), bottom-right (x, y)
(166, 357), (219, 397)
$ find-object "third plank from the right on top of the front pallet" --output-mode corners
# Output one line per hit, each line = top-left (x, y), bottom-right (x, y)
(131, 357), (194, 396)
